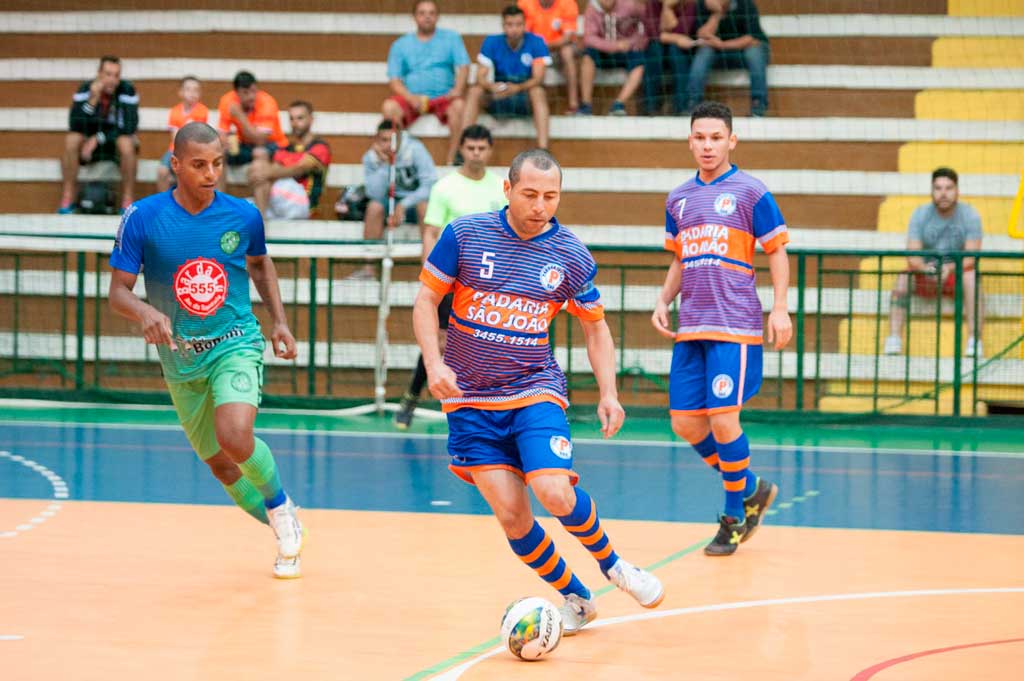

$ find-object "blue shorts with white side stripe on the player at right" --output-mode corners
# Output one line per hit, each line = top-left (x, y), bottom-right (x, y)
(669, 340), (762, 416)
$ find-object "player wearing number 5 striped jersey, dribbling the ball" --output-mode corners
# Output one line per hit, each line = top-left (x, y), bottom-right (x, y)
(413, 150), (665, 635)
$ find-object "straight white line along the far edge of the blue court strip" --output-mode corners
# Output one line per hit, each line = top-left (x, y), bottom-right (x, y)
(0, 411), (1024, 459)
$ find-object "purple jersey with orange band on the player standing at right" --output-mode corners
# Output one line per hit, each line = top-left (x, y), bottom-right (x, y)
(665, 166), (790, 345)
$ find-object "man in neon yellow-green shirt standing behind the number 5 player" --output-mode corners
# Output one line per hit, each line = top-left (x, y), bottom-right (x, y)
(394, 125), (507, 430)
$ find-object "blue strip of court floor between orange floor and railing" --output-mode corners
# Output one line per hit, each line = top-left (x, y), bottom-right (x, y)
(0, 422), (1024, 535)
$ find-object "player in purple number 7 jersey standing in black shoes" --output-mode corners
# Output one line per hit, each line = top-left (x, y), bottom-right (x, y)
(651, 101), (793, 556)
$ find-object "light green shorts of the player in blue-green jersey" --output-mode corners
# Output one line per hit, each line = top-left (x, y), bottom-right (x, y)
(167, 348), (263, 461)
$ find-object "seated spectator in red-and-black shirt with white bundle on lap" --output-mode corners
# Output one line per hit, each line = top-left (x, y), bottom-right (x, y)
(249, 100), (331, 220)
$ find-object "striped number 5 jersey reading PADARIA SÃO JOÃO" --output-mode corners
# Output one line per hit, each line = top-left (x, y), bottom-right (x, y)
(420, 209), (604, 412)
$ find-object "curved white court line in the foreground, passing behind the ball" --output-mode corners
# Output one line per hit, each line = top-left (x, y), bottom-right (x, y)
(432, 587), (1024, 681)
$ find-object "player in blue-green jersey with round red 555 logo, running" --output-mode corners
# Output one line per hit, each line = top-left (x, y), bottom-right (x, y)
(110, 123), (303, 579)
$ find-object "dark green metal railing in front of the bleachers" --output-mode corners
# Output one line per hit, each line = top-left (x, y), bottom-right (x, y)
(0, 240), (1024, 417)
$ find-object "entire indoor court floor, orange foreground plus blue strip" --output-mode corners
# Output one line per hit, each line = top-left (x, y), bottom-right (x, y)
(0, 411), (1024, 681)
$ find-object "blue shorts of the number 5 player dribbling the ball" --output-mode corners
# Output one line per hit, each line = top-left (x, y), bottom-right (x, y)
(447, 402), (580, 484)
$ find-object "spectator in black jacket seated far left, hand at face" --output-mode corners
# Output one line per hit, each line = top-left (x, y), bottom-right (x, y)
(57, 54), (138, 214)
